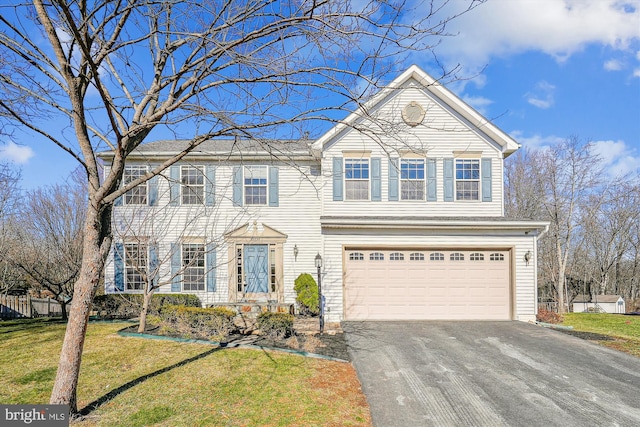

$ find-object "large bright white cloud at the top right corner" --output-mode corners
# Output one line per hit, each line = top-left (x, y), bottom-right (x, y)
(438, 0), (640, 72)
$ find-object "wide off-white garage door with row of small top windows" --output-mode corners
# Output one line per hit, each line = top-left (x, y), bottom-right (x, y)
(344, 249), (511, 320)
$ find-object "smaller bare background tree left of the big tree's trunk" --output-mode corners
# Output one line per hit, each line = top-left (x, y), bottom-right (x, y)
(9, 174), (87, 320)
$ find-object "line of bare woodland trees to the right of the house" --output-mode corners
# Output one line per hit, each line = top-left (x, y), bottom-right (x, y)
(505, 137), (640, 312)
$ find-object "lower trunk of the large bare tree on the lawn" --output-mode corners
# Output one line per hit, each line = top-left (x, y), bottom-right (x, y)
(49, 205), (111, 414)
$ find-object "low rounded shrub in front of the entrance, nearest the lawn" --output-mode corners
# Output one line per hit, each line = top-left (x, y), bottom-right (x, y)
(160, 305), (236, 341)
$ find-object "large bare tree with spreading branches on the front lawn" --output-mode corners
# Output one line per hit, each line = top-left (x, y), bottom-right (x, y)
(0, 0), (482, 412)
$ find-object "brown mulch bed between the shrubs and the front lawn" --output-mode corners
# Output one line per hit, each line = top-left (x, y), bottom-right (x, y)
(122, 325), (351, 361)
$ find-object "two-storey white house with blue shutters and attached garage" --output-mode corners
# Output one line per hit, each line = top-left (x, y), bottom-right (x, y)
(101, 66), (548, 322)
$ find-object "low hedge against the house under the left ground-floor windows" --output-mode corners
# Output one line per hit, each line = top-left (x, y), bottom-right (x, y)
(93, 294), (201, 319)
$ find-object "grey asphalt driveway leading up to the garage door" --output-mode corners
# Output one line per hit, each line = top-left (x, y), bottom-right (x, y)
(343, 322), (640, 427)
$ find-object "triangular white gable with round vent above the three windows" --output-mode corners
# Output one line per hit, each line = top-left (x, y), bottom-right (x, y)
(314, 66), (519, 157)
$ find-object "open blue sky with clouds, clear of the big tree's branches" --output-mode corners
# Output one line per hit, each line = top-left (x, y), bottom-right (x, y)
(0, 0), (640, 189)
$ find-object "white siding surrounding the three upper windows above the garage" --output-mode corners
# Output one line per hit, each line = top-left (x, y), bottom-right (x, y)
(322, 84), (503, 217)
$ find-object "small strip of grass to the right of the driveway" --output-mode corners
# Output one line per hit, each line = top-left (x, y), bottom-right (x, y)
(562, 313), (640, 357)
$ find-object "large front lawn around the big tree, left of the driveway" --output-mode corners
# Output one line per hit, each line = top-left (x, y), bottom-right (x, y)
(0, 321), (371, 426)
